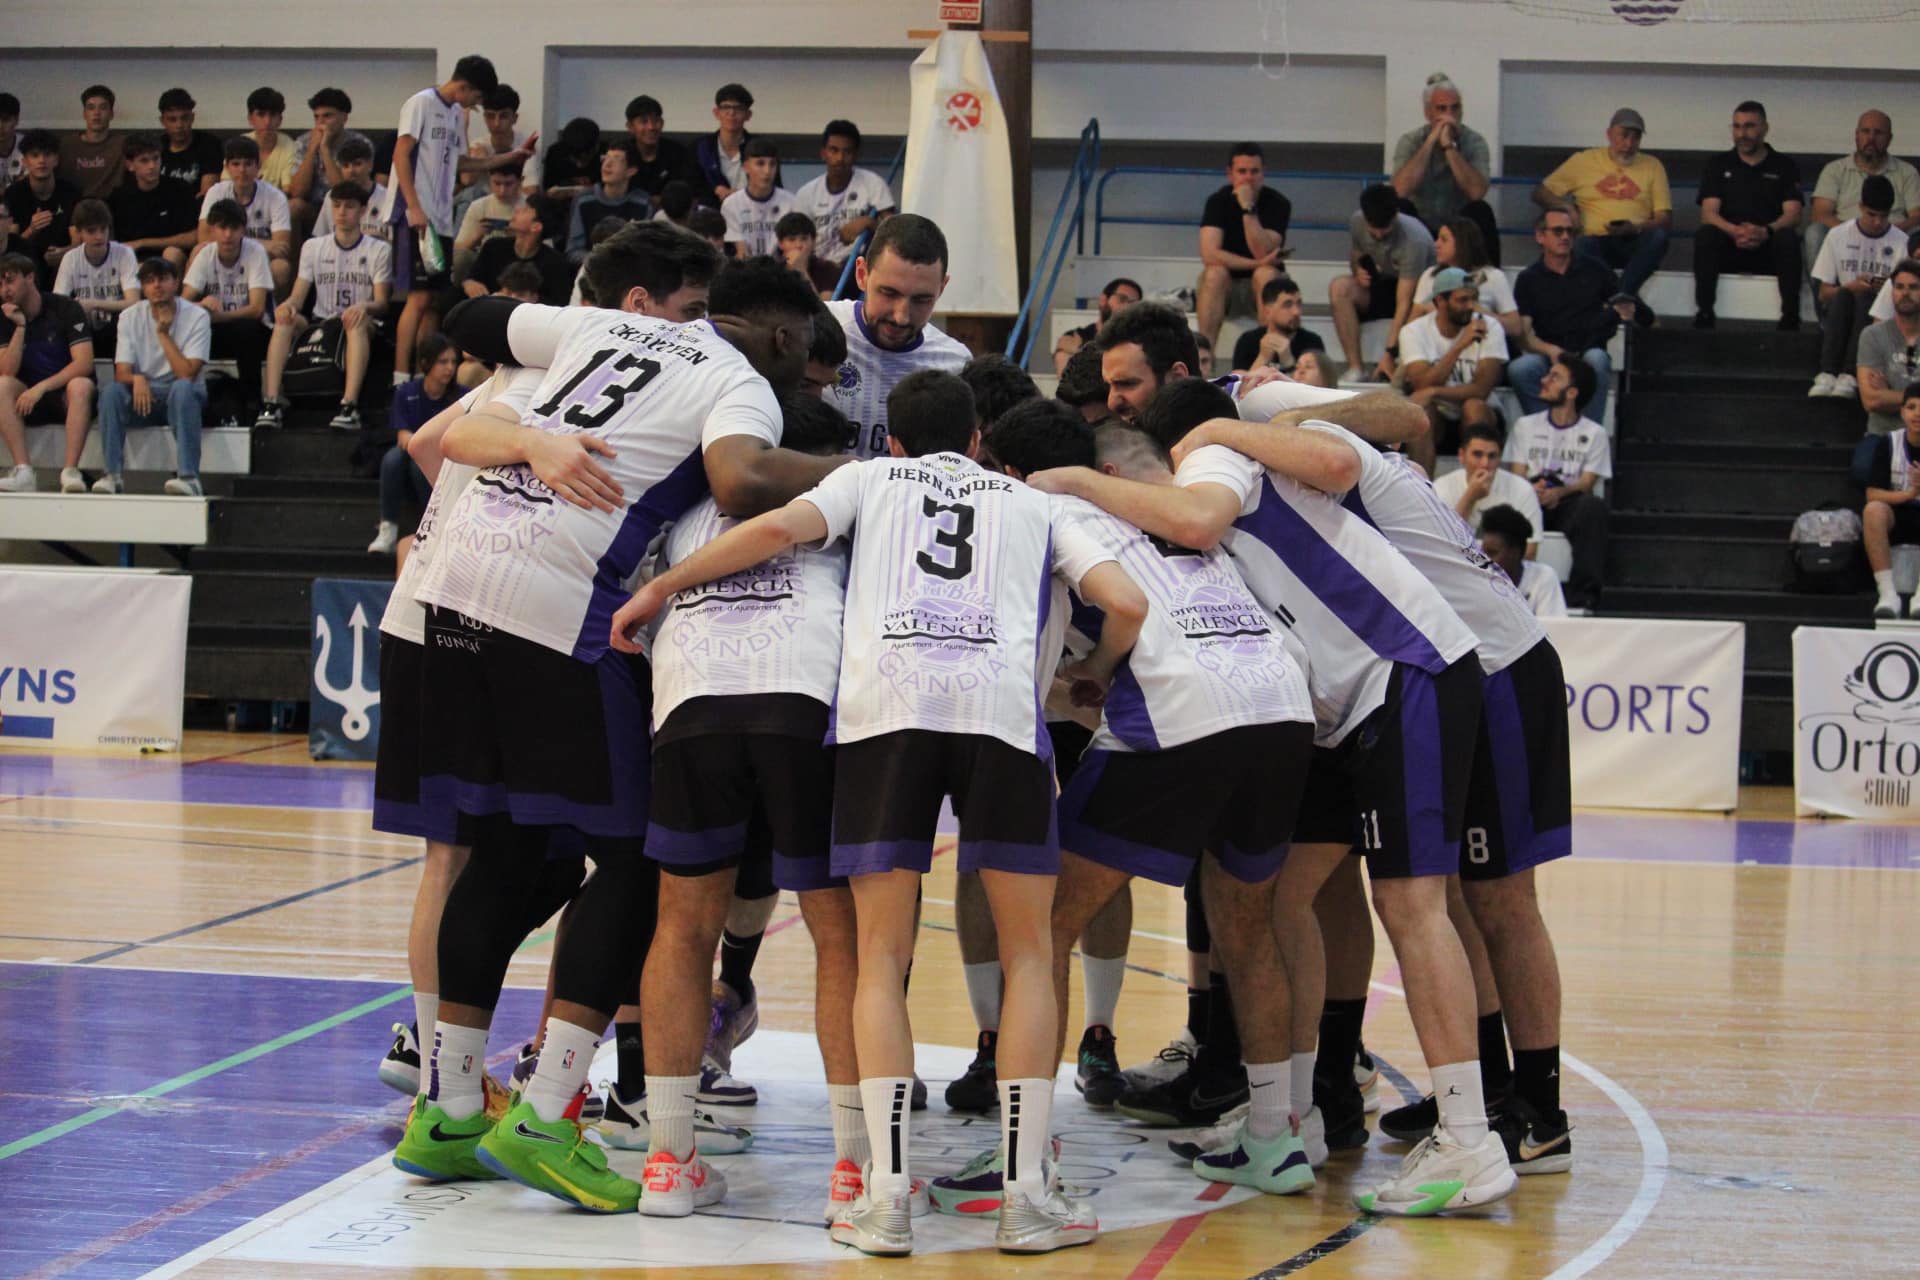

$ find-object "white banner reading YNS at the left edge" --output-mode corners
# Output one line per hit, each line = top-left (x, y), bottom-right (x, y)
(0, 566), (194, 750)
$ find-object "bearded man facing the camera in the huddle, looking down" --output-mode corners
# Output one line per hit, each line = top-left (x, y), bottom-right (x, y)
(828, 213), (973, 459)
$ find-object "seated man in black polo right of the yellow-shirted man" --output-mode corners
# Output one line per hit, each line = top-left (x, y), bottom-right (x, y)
(1693, 100), (1803, 330)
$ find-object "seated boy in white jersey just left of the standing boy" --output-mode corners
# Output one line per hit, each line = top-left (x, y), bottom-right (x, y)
(255, 182), (394, 432)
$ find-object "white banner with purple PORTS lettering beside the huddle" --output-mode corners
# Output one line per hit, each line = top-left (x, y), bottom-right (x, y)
(1544, 618), (1747, 810)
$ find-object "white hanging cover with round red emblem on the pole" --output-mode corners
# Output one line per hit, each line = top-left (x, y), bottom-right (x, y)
(900, 31), (1020, 315)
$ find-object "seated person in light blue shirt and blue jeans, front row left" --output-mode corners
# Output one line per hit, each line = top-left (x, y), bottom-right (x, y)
(94, 257), (213, 497)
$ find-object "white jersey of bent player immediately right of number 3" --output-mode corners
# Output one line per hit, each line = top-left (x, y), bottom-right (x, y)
(1054, 499), (1313, 750)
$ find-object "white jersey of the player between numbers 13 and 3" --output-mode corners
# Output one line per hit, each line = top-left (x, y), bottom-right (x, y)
(651, 497), (847, 733)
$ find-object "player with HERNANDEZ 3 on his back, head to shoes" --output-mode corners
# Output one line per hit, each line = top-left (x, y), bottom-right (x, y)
(614, 368), (1146, 1255)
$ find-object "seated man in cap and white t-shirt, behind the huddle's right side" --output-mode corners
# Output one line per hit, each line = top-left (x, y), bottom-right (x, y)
(1400, 267), (1507, 474)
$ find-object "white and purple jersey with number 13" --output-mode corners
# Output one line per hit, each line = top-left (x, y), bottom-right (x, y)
(419, 303), (781, 662)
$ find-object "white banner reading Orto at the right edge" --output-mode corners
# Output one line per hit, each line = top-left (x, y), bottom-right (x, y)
(1793, 628), (1920, 818)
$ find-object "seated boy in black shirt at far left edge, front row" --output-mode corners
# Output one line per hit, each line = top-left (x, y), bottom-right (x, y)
(0, 253), (94, 493)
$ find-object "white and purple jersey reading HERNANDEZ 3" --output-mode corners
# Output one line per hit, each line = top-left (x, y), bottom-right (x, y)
(803, 453), (1114, 758)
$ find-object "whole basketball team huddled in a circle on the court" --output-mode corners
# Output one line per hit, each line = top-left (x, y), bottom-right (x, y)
(362, 205), (1572, 1255)
